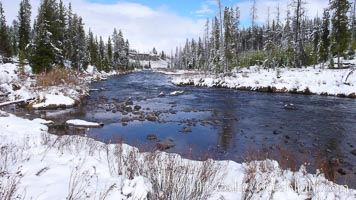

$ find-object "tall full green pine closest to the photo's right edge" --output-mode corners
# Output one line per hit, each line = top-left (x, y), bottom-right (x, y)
(330, 0), (351, 67)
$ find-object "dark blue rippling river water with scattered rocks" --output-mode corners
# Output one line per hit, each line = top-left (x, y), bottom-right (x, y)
(8, 71), (356, 188)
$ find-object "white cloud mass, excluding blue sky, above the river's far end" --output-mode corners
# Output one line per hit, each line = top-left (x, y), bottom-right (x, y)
(2, 0), (205, 53)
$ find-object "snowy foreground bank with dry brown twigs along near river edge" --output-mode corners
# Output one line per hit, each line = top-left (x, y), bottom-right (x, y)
(0, 111), (356, 200)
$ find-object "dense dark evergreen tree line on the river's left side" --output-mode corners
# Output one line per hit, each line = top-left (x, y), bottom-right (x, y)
(0, 0), (132, 73)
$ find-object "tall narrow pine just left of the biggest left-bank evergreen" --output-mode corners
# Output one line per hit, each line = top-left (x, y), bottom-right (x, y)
(17, 0), (31, 55)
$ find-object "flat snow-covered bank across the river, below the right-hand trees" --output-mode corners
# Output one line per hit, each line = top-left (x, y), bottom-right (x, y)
(172, 66), (356, 98)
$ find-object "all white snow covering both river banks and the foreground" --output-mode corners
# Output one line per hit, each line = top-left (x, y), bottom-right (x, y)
(0, 61), (356, 200)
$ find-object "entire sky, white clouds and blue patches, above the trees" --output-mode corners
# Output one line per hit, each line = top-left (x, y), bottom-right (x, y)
(0, 0), (328, 54)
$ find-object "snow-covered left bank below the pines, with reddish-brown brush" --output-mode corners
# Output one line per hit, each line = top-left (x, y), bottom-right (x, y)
(0, 63), (119, 109)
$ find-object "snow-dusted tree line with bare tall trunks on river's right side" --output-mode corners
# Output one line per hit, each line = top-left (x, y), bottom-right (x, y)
(172, 0), (356, 73)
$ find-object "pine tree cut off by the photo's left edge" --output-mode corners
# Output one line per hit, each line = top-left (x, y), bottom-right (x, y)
(0, 2), (12, 57)
